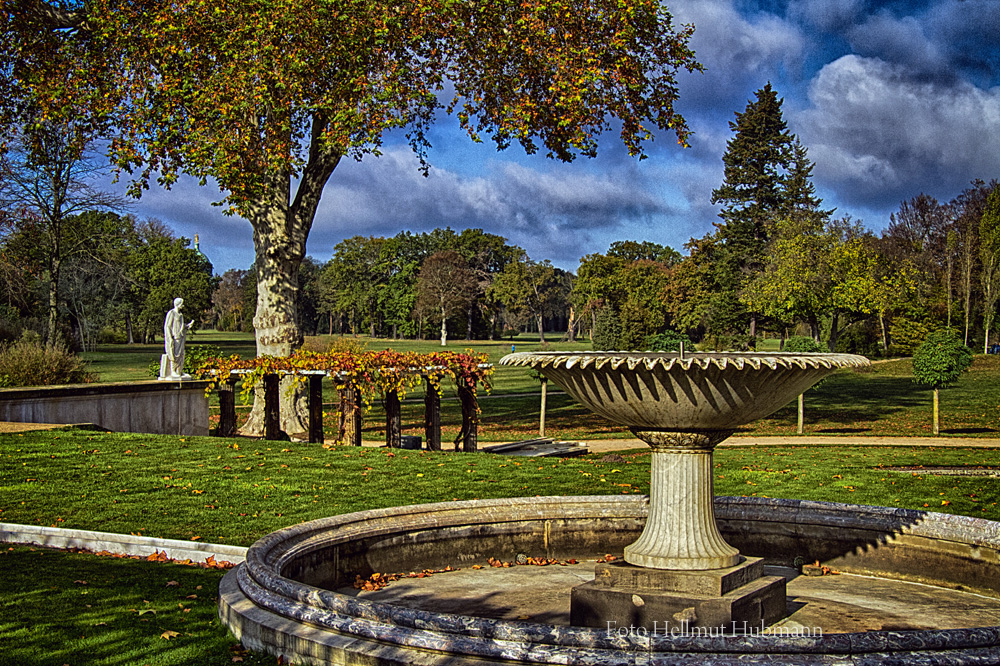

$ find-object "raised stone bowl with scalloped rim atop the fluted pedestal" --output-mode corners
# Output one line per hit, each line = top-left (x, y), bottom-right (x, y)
(500, 351), (870, 432)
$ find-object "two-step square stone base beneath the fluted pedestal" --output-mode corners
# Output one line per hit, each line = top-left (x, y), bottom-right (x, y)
(570, 558), (785, 634)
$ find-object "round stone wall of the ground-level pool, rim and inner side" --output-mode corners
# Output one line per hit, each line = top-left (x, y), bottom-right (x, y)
(219, 496), (1000, 666)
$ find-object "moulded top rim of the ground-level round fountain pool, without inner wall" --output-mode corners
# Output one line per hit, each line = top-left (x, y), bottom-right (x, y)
(220, 496), (1000, 664)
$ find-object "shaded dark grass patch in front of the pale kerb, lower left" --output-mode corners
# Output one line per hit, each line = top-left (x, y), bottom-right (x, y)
(0, 546), (276, 666)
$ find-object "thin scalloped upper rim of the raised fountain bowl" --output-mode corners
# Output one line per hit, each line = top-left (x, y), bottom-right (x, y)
(500, 351), (871, 372)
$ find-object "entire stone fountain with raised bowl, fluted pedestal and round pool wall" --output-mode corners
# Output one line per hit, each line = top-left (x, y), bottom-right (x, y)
(219, 352), (1000, 666)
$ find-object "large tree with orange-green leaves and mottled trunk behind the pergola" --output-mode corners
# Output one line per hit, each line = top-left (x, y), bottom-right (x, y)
(0, 0), (700, 433)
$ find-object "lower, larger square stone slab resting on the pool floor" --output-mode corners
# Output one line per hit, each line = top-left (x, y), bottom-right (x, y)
(570, 576), (785, 633)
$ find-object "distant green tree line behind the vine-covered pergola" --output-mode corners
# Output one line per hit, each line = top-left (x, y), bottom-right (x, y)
(212, 228), (572, 344)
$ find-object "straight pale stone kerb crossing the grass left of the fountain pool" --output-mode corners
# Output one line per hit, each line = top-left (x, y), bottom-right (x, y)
(0, 523), (248, 564)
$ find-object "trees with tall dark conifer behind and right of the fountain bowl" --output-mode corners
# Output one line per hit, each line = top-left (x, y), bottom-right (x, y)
(571, 85), (1000, 356)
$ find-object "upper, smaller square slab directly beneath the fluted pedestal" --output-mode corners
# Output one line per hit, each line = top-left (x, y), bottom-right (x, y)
(594, 557), (764, 596)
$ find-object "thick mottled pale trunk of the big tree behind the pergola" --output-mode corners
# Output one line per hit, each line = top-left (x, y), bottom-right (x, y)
(240, 120), (340, 436)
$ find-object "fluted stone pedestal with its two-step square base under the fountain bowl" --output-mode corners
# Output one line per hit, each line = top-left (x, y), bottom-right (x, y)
(570, 429), (785, 633)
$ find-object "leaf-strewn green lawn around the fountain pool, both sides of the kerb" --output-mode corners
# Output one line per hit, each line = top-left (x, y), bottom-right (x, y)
(0, 430), (1000, 666)
